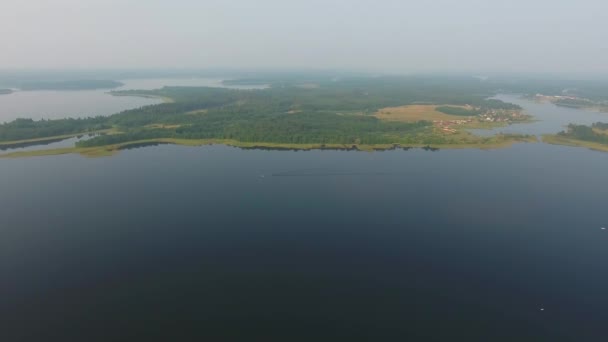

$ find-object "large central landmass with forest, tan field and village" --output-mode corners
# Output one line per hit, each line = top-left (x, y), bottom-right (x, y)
(0, 77), (537, 157)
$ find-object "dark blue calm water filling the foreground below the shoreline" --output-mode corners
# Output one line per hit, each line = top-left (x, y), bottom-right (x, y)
(0, 144), (608, 341)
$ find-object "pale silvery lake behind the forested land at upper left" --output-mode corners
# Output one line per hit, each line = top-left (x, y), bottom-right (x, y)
(0, 78), (265, 122)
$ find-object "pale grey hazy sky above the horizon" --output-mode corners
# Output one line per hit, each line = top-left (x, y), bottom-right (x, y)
(0, 0), (608, 73)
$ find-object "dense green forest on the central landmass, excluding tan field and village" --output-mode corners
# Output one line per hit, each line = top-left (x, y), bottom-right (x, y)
(0, 77), (518, 147)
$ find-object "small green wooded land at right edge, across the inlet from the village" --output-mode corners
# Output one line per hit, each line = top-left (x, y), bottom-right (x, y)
(543, 122), (608, 152)
